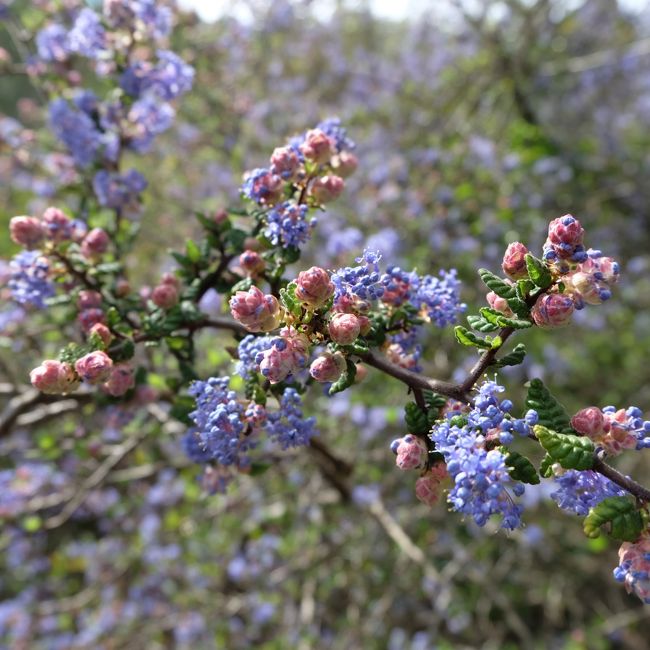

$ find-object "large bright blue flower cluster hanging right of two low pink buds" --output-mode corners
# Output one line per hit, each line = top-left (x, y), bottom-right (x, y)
(430, 381), (534, 530)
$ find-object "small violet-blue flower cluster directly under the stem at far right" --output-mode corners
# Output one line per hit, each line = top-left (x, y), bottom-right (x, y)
(551, 469), (627, 516)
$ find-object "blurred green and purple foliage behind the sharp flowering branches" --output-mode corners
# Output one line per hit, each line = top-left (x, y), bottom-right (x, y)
(0, 0), (650, 650)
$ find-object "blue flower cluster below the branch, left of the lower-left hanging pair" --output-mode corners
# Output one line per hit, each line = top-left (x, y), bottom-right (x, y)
(189, 377), (255, 467)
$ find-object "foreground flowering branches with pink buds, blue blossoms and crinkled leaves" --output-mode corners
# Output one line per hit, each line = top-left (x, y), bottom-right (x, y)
(0, 1), (650, 644)
